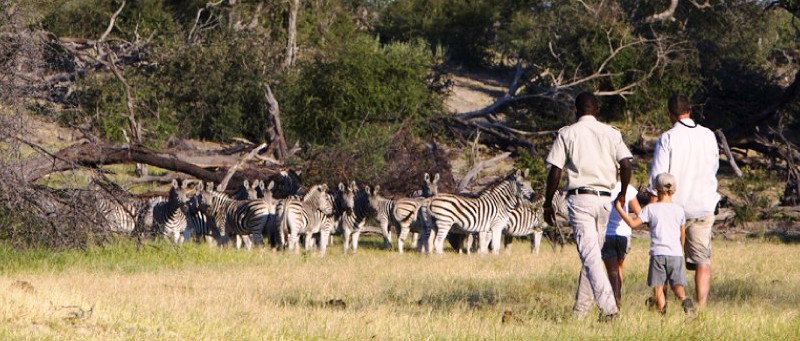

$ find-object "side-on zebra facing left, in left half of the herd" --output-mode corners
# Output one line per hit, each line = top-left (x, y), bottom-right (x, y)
(195, 183), (275, 250)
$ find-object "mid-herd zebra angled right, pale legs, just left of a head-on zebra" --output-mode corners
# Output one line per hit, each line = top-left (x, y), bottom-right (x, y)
(278, 184), (334, 254)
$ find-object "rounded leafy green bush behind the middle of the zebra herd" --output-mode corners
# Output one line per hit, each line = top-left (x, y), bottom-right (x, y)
(281, 35), (442, 145)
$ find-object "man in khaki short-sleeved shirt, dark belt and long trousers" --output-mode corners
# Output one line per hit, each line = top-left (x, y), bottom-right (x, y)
(543, 92), (632, 320)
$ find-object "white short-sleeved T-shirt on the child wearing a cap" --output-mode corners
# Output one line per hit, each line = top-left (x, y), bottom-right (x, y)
(639, 202), (686, 257)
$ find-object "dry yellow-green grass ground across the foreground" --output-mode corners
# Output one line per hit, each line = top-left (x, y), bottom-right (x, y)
(0, 234), (800, 340)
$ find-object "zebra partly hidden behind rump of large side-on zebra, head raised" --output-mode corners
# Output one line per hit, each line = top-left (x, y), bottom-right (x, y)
(392, 173), (439, 253)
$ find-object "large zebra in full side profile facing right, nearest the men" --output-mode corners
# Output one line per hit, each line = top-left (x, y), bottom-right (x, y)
(422, 170), (527, 254)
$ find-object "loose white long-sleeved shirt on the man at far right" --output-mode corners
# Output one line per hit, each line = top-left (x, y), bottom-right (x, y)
(648, 118), (720, 219)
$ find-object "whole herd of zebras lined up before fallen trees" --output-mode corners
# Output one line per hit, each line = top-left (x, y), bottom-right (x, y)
(98, 170), (558, 254)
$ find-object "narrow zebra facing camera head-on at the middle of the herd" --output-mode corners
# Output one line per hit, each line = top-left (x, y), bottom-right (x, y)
(337, 181), (375, 254)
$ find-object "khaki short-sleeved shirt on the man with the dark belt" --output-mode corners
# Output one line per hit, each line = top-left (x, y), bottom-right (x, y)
(547, 115), (633, 192)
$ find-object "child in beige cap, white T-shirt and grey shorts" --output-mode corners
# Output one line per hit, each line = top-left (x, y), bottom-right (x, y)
(615, 173), (695, 314)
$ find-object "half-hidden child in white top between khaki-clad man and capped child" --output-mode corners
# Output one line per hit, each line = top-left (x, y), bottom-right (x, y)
(601, 182), (642, 307)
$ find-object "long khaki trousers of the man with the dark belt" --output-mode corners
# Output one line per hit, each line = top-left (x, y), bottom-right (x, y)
(567, 194), (618, 317)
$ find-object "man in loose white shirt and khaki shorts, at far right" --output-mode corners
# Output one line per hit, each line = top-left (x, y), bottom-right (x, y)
(648, 95), (720, 308)
